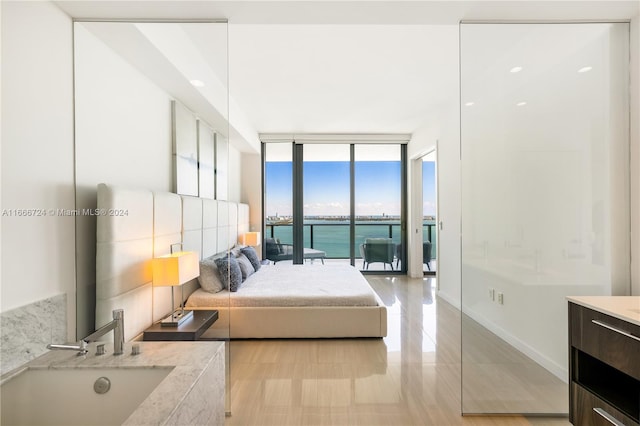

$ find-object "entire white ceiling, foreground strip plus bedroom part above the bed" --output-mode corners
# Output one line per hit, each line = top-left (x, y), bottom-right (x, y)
(57, 0), (639, 151)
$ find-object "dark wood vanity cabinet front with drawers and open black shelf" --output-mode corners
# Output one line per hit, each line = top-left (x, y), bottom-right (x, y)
(569, 303), (640, 426)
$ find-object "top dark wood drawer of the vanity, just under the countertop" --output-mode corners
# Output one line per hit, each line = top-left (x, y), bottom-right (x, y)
(571, 305), (640, 380)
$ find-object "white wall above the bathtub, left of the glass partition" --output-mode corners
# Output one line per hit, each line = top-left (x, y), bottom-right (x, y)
(1, 2), (75, 336)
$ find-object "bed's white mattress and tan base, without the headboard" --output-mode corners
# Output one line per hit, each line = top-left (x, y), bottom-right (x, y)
(187, 263), (387, 338)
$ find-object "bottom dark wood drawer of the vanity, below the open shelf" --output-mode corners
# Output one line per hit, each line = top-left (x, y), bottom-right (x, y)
(571, 382), (639, 426)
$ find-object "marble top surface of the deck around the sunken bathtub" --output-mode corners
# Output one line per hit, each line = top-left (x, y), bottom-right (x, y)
(2, 341), (225, 425)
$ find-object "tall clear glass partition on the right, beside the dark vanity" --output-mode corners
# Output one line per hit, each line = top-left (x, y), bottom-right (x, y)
(460, 23), (629, 414)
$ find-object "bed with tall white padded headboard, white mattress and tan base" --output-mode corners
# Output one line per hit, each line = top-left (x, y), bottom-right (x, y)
(96, 184), (387, 340)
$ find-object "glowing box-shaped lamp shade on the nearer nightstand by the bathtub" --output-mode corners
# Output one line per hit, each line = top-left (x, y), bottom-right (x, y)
(152, 251), (200, 287)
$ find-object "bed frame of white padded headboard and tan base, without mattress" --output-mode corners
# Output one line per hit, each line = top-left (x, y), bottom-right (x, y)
(96, 184), (387, 340)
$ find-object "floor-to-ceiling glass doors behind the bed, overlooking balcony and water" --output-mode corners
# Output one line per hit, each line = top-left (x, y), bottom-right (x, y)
(263, 141), (406, 272)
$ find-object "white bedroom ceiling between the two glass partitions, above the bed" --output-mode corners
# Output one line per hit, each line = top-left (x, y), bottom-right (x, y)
(229, 25), (458, 133)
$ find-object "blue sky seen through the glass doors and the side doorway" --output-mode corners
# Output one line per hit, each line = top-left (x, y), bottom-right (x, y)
(266, 161), (436, 216)
